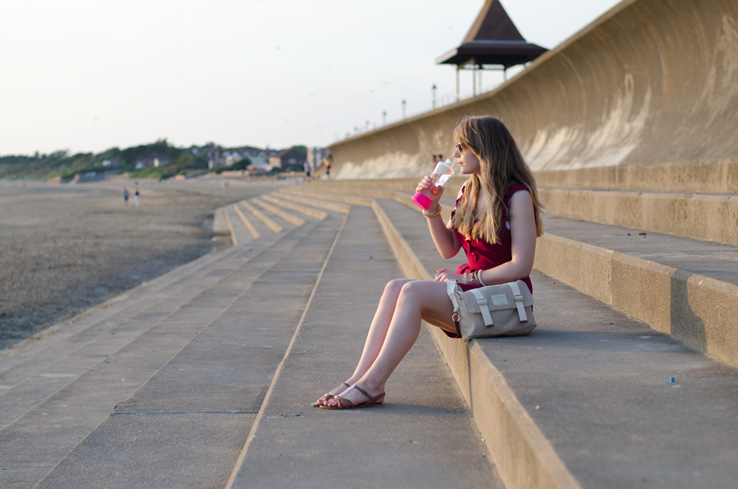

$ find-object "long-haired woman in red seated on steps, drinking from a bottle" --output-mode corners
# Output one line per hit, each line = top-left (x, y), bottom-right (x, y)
(313, 117), (543, 409)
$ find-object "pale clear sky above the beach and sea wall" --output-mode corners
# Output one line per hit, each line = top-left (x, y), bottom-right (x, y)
(0, 0), (619, 155)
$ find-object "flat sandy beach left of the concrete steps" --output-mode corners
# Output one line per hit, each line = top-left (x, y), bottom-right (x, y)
(0, 178), (286, 350)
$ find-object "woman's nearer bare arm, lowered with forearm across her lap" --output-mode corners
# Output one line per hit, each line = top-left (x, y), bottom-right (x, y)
(479, 190), (536, 285)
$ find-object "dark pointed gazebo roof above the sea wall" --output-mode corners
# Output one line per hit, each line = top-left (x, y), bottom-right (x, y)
(436, 0), (547, 69)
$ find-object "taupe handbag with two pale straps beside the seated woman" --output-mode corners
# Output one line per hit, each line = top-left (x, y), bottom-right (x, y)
(446, 280), (536, 341)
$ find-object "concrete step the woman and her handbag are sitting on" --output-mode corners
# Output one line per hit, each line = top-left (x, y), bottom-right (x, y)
(370, 195), (738, 489)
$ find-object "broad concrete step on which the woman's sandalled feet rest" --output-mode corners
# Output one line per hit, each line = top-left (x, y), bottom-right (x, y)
(228, 206), (503, 488)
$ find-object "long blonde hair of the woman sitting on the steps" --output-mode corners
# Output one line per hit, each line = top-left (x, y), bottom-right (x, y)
(453, 116), (543, 243)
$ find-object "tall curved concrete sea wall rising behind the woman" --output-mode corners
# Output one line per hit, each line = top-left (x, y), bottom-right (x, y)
(330, 0), (738, 178)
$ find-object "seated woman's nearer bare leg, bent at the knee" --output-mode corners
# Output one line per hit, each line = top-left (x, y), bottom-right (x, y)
(327, 281), (453, 405)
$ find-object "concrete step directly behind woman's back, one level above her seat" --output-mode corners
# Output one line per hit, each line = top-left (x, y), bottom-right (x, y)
(535, 216), (738, 366)
